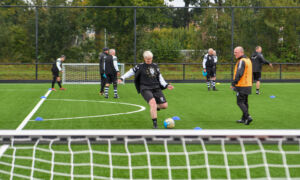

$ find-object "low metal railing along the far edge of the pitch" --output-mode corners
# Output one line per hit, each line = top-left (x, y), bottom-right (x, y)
(0, 63), (300, 82)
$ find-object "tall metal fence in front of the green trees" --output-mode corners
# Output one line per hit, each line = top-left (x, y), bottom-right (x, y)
(0, 5), (300, 80)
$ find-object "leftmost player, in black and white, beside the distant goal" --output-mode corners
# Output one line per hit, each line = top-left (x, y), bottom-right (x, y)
(51, 55), (66, 91)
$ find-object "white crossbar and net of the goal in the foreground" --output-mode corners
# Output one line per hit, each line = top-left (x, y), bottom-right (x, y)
(0, 129), (300, 180)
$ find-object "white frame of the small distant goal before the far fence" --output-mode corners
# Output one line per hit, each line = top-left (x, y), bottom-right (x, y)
(62, 63), (125, 84)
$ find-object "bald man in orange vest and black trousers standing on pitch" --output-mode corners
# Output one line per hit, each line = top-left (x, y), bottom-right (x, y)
(231, 46), (252, 125)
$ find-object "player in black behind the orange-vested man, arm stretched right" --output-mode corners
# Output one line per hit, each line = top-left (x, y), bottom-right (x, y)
(251, 46), (273, 95)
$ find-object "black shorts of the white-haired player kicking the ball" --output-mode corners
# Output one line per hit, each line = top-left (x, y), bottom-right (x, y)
(141, 89), (167, 104)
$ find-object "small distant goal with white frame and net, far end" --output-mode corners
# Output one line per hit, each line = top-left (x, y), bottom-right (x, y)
(62, 63), (125, 84)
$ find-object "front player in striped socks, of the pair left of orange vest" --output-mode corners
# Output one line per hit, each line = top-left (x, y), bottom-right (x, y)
(202, 48), (218, 91)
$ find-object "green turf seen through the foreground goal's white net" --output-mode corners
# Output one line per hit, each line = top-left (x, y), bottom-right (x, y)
(0, 141), (300, 179)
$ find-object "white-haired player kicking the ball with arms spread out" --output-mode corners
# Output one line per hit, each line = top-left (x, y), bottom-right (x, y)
(119, 51), (174, 129)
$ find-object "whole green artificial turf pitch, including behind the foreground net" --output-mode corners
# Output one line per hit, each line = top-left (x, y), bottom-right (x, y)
(0, 83), (300, 179)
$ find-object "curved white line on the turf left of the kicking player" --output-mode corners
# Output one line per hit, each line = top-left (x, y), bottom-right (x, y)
(30, 99), (146, 121)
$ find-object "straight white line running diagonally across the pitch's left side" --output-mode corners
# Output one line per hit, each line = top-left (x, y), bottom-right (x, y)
(0, 90), (51, 158)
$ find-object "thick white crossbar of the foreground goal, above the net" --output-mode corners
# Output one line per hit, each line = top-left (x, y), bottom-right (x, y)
(0, 129), (300, 144)
